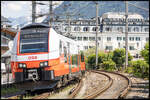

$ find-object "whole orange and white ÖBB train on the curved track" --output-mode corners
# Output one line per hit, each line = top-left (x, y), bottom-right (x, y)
(11, 23), (85, 90)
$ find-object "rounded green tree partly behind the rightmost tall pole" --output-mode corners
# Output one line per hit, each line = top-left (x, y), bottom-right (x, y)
(112, 48), (133, 67)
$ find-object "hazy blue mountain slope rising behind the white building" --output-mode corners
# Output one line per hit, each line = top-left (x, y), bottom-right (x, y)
(54, 1), (149, 18)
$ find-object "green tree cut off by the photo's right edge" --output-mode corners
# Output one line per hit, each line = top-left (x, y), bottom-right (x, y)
(141, 42), (149, 64)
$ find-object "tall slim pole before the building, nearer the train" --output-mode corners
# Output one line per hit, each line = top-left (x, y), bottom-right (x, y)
(95, 1), (98, 68)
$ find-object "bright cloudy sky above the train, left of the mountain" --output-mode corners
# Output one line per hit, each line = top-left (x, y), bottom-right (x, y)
(1, 1), (63, 18)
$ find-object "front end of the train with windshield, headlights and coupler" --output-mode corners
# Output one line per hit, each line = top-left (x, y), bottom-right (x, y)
(11, 24), (58, 83)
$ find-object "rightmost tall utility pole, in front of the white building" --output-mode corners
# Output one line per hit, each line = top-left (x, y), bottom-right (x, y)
(124, 1), (128, 69)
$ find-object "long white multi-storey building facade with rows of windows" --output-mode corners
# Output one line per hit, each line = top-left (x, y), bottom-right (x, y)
(52, 12), (149, 56)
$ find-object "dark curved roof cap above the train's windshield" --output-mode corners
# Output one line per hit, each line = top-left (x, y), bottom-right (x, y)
(21, 23), (50, 30)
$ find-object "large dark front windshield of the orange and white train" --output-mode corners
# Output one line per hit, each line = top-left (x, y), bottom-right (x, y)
(20, 29), (48, 53)
